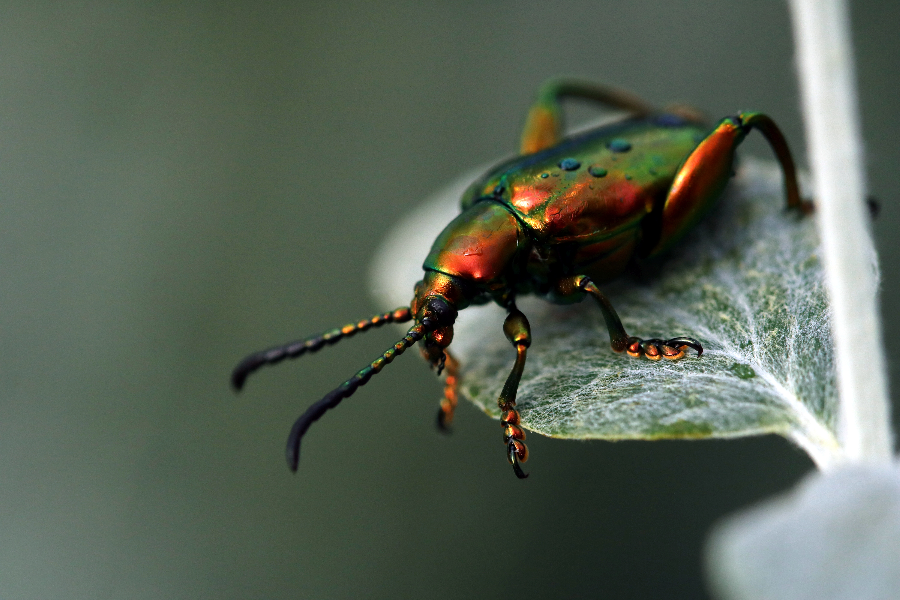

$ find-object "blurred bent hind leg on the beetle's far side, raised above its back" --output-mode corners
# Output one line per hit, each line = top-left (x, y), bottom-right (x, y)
(520, 79), (653, 154)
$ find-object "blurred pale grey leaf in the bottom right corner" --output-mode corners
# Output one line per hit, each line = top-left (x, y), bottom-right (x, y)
(706, 464), (900, 600)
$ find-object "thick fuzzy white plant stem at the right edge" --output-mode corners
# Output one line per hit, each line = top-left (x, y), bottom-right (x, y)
(790, 0), (892, 461)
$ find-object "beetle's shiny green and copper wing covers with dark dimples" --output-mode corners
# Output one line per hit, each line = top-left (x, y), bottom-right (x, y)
(463, 115), (705, 244)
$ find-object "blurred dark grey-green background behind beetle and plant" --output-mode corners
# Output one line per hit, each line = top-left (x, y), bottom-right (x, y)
(0, 0), (900, 599)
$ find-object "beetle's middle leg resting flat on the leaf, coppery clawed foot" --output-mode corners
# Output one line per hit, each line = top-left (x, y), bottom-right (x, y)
(557, 275), (703, 360)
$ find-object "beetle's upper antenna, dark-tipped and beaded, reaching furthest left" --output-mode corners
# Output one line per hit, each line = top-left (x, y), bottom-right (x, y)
(231, 306), (412, 391)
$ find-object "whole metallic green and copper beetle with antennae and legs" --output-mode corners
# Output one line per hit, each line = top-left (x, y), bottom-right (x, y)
(231, 79), (811, 478)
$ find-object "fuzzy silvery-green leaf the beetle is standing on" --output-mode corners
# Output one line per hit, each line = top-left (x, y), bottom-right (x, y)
(373, 160), (840, 464)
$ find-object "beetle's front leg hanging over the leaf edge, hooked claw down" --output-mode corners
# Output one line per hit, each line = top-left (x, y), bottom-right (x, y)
(497, 307), (531, 479)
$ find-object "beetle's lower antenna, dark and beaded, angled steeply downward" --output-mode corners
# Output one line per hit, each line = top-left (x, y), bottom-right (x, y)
(286, 316), (437, 473)
